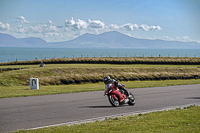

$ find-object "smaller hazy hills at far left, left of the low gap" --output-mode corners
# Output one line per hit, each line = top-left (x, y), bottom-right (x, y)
(0, 33), (47, 47)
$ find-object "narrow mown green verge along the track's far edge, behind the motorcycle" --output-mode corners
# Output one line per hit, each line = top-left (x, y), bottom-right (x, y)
(0, 79), (200, 98)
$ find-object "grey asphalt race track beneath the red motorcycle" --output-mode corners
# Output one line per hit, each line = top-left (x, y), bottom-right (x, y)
(0, 84), (200, 133)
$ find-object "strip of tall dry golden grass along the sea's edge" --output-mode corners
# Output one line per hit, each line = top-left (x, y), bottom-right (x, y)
(0, 57), (200, 66)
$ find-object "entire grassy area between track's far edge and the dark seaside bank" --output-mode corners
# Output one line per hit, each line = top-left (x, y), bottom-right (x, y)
(0, 64), (200, 98)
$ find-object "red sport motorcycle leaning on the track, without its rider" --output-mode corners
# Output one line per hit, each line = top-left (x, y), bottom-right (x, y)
(104, 83), (135, 107)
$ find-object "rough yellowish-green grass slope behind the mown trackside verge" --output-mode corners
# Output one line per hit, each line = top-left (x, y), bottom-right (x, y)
(0, 64), (200, 86)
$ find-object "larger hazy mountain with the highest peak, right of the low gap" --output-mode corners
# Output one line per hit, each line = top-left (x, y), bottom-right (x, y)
(48, 31), (200, 49)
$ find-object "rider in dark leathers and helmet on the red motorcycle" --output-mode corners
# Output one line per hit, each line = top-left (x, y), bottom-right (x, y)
(103, 76), (130, 97)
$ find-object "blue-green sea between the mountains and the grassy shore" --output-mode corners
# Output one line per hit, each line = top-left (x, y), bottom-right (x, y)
(0, 47), (200, 62)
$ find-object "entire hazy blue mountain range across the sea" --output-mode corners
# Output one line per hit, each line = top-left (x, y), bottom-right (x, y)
(0, 31), (200, 49)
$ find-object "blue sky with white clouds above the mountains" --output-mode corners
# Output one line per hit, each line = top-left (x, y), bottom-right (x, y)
(0, 0), (200, 43)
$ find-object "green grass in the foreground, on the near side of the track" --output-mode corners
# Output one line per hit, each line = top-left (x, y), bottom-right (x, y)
(14, 106), (200, 133)
